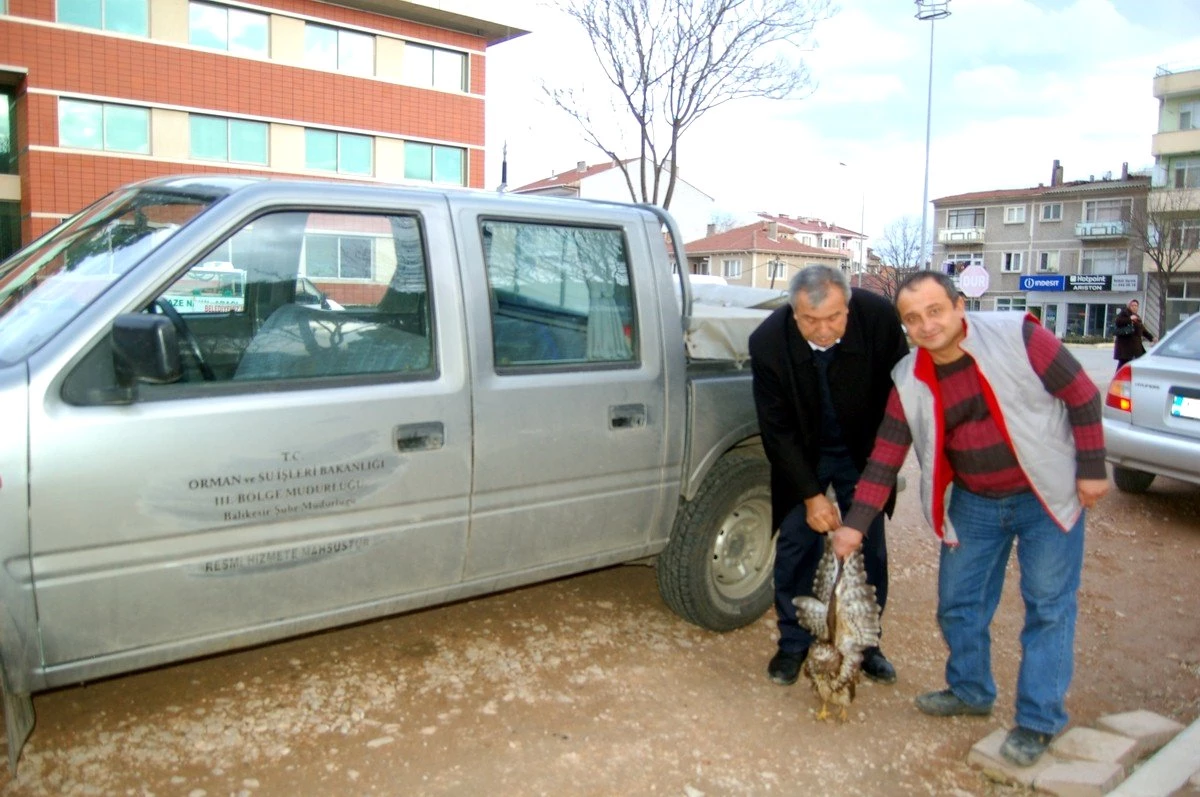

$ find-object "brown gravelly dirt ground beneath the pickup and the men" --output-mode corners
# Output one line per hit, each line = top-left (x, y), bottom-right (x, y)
(0, 451), (1200, 797)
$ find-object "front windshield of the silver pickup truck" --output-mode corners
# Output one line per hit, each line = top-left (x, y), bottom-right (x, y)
(0, 188), (215, 364)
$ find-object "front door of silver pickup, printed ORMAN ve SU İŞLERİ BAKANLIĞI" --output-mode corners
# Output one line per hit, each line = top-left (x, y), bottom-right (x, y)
(29, 195), (472, 681)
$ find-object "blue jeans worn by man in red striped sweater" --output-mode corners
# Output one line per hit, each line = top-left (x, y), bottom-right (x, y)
(937, 486), (1084, 733)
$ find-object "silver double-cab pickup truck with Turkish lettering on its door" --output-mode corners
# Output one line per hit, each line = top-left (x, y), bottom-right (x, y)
(0, 176), (774, 767)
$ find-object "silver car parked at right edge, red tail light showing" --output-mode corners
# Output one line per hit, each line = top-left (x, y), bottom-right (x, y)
(1104, 314), (1200, 492)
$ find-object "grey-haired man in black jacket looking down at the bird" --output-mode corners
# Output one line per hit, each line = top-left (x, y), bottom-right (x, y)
(750, 265), (908, 685)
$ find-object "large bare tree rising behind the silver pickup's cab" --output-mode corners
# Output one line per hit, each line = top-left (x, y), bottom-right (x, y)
(544, 0), (833, 208)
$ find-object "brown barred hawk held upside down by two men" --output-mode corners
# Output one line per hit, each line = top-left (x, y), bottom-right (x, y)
(793, 537), (880, 721)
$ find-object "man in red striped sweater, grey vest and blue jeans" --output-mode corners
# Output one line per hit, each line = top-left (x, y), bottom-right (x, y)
(834, 271), (1109, 766)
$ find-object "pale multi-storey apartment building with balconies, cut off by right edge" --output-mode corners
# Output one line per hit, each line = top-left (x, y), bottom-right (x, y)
(1146, 66), (1200, 329)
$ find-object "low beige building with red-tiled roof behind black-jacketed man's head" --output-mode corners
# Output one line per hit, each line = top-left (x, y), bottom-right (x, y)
(684, 214), (853, 290)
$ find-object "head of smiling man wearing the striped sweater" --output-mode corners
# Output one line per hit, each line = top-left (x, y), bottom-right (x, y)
(896, 271), (966, 362)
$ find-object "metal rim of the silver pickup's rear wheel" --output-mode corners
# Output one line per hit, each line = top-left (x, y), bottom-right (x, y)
(712, 497), (775, 599)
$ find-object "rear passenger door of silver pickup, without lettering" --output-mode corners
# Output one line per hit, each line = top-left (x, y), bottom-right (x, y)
(455, 203), (682, 580)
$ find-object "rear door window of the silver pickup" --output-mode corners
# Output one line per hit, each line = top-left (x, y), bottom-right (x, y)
(481, 220), (637, 373)
